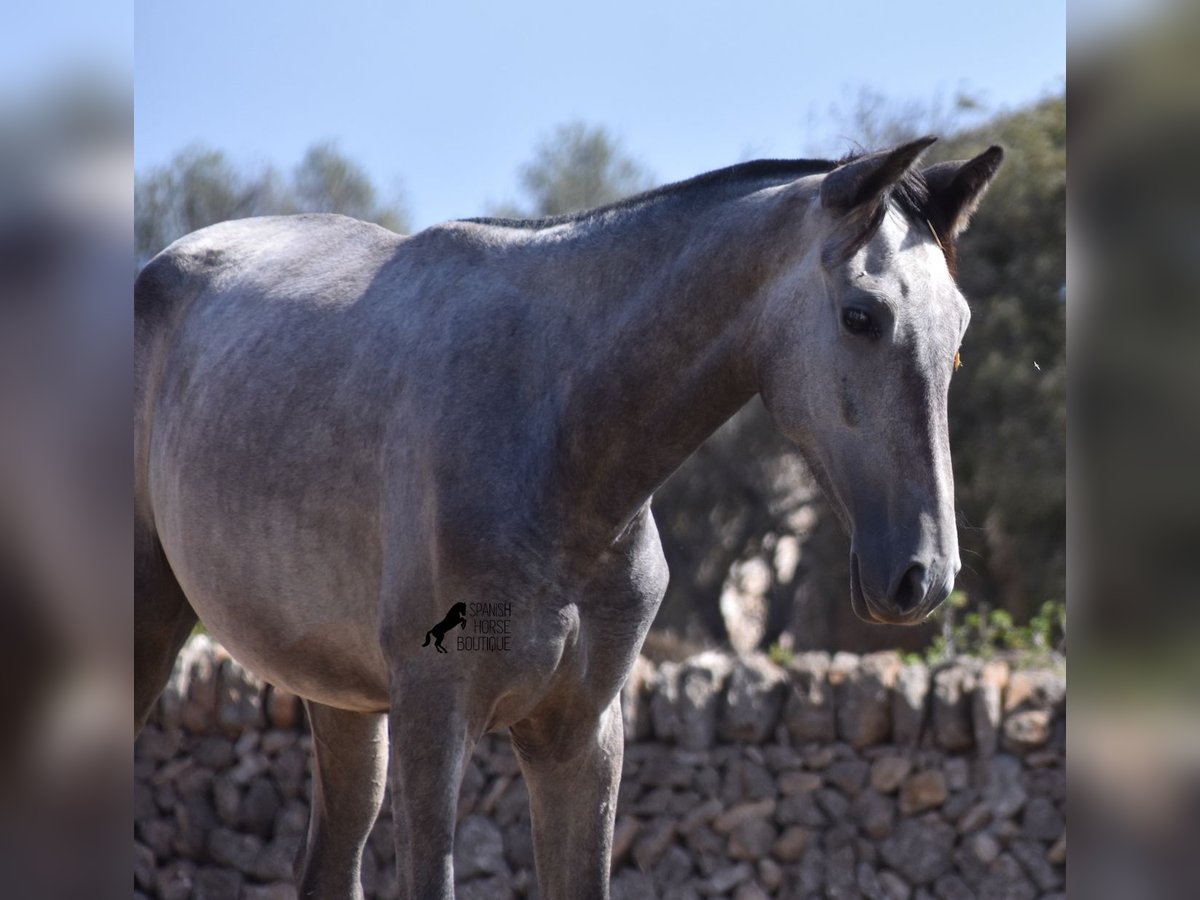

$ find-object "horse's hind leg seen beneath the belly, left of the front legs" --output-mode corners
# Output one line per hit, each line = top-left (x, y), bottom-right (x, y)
(296, 701), (388, 900)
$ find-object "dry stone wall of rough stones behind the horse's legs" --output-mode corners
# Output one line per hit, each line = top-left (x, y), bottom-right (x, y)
(133, 637), (1067, 900)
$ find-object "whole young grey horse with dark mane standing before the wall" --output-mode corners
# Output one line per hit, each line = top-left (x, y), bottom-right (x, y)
(134, 138), (1002, 900)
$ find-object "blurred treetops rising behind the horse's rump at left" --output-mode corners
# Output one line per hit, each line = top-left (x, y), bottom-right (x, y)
(133, 143), (407, 264)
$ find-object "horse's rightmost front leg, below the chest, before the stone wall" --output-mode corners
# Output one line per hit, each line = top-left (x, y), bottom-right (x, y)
(512, 695), (625, 900)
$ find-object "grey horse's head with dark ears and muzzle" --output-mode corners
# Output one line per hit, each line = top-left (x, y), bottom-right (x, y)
(756, 138), (1003, 624)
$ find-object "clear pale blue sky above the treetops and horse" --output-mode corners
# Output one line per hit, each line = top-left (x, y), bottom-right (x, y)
(134, 0), (1066, 227)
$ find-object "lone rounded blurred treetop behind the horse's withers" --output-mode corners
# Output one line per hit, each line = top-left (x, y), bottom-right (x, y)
(493, 121), (653, 217)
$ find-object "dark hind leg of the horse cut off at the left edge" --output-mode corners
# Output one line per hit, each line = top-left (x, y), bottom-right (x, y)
(133, 524), (197, 734)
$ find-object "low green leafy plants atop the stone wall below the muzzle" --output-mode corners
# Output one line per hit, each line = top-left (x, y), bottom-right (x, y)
(906, 590), (1067, 665)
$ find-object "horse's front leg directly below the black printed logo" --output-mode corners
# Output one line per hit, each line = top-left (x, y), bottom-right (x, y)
(388, 677), (475, 900)
